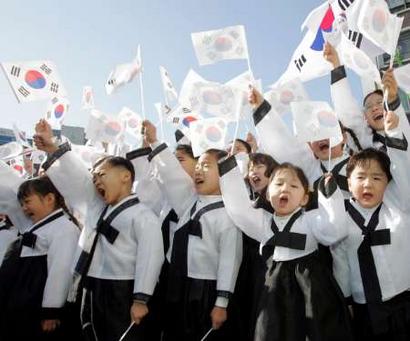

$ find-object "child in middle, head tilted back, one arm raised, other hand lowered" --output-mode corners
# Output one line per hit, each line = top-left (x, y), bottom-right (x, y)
(144, 121), (242, 341)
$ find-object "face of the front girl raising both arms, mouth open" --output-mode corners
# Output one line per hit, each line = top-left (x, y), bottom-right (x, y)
(268, 168), (309, 216)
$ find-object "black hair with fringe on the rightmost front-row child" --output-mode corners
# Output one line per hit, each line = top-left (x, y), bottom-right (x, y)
(346, 148), (392, 181)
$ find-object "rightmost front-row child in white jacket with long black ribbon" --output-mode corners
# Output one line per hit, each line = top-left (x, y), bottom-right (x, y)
(333, 112), (410, 340)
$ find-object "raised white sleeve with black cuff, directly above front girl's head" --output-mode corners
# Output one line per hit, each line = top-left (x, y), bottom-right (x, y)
(253, 100), (322, 184)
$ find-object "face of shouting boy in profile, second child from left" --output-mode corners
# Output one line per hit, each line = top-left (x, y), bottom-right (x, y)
(93, 161), (132, 205)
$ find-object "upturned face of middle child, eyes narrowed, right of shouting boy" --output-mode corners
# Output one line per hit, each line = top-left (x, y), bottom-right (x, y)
(194, 152), (221, 195)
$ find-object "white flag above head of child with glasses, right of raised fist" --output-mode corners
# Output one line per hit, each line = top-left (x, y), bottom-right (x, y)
(337, 34), (381, 83)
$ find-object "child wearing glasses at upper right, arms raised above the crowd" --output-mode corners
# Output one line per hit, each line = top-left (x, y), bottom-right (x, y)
(323, 43), (410, 151)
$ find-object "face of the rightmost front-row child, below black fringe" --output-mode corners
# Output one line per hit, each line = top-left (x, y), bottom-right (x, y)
(348, 159), (389, 208)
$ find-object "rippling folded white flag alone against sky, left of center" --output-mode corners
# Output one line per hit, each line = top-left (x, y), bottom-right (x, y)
(105, 45), (142, 95)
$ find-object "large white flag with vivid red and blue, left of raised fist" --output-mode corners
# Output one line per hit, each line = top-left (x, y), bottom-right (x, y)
(278, 5), (334, 84)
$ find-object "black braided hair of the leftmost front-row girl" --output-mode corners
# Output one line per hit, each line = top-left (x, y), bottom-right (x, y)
(17, 176), (79, 226)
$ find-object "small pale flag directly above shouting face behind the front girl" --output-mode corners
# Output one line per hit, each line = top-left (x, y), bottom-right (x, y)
(290, 101), (343, 145)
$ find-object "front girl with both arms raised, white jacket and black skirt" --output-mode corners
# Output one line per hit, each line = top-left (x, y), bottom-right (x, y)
(219, 157), (351, 341)
